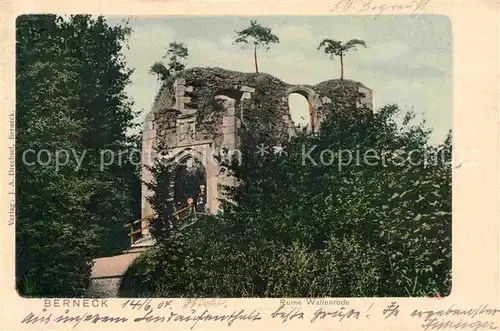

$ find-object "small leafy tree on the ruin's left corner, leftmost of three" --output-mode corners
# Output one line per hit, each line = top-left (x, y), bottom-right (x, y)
(149, 41), (189, 80)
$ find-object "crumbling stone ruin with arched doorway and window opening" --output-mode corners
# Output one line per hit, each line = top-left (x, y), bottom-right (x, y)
(142, 68), (373, 239)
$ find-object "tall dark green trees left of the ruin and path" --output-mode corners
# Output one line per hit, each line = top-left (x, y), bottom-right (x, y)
(16, 15), (140, 296)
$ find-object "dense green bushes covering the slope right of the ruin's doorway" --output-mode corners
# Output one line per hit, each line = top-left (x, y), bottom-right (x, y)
(122, 106), (451, 297)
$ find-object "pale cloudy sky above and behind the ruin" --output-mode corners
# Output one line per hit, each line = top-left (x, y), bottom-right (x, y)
(106, 15), (452, 143)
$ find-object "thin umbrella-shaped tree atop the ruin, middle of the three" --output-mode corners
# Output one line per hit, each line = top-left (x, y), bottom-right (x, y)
(234, 21), (280, 73)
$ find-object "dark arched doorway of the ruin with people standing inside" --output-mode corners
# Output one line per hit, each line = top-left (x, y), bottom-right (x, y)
(174, 155), (207, 216)
